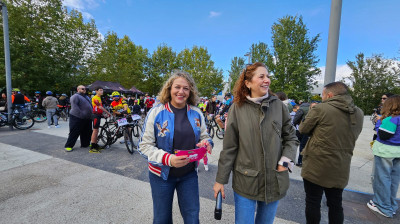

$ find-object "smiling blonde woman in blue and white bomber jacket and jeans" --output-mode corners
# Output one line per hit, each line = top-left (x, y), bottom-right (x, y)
(138, 71), (213, 224)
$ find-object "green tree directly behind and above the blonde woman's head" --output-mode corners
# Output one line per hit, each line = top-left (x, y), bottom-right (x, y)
(177, 46), (223, 96)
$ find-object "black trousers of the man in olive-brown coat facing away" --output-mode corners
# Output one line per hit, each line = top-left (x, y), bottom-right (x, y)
(303, 179), (344, 224)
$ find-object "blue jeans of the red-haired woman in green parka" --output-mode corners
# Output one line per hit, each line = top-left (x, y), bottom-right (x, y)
(233, 192), (279, 224)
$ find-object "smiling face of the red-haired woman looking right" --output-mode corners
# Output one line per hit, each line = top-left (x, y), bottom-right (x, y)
(245, 67), (271, 98)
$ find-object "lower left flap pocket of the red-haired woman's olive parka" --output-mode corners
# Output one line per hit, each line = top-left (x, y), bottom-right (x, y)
(233, 167), (258, 196)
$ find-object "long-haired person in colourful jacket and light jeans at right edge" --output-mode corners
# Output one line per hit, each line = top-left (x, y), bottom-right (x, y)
(367, 95), (400, 218)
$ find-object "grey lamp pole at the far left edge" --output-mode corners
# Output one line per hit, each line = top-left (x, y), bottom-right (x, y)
(0, 1), (12, 129)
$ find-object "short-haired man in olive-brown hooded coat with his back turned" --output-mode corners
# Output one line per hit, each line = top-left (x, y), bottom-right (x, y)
(299, 82), (364, 224)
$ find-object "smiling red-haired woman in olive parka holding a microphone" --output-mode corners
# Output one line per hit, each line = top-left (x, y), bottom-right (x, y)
(214, 62), (298, 224)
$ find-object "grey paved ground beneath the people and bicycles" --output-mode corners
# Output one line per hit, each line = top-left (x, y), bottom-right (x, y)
(0, 117), (400, 224)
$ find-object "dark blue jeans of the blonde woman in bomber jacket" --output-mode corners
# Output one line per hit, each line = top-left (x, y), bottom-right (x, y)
(149, 170), (200, 224)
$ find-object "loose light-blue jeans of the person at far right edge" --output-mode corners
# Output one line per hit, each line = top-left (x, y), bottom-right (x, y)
(372, 156), (400, 217)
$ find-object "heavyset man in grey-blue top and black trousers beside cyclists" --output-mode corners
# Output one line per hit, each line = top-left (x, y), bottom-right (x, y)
(65, 85), (93, 152)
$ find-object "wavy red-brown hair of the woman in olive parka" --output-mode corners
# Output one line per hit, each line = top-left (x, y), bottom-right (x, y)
(233, 62), (273, 106)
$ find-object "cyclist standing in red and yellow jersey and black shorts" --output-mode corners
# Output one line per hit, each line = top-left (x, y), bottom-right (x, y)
(89, 87), (111, 153)
